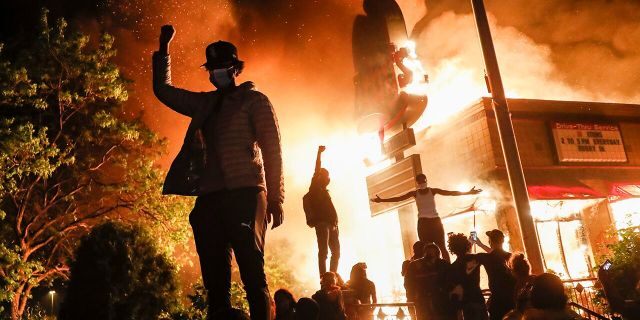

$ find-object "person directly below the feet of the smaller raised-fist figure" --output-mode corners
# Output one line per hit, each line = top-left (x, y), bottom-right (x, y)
(311, 272), (347, 320)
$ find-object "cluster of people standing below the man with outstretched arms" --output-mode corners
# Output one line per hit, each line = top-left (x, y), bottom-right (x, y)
(403, 230), (581, 320)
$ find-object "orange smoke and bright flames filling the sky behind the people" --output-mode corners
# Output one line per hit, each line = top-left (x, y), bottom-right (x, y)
(51, 0), (640, 300)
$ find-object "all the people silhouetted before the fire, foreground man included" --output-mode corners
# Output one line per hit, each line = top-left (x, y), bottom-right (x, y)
(152, 25), (592, 320)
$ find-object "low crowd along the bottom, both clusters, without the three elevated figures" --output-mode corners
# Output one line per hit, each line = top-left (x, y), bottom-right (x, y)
(220, 230), (582, 320)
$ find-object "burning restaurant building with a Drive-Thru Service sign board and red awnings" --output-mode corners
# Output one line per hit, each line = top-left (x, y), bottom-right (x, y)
(408, 98), (640, 279)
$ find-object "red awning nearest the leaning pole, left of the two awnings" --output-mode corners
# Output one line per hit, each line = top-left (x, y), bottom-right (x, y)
(526, 175), (607, 200)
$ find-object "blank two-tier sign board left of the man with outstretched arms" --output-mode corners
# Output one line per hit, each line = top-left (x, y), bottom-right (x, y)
(367, 154), (422, 216)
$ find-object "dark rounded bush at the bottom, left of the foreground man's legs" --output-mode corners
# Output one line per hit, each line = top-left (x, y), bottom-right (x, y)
(60, 222), (178, 320)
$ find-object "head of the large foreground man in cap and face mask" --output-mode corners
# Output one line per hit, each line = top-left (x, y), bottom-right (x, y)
(202, 41), (244, 89)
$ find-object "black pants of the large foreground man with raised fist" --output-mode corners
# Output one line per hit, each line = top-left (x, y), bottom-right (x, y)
(189, 188), (271, 320)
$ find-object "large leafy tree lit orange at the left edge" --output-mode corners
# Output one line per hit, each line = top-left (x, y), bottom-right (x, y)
(0, 10), (191, 319)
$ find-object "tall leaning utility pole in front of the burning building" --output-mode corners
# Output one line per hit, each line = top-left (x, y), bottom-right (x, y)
(471, 0), (544, 274)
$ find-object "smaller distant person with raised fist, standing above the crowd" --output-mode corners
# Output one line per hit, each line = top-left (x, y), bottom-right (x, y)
(308, 146), (340, 276)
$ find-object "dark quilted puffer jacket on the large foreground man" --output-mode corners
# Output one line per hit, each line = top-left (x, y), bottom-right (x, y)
(153, 52), (284, 203)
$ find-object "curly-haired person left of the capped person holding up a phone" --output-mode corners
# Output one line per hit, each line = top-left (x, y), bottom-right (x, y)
(449, 233), (488, 320)
